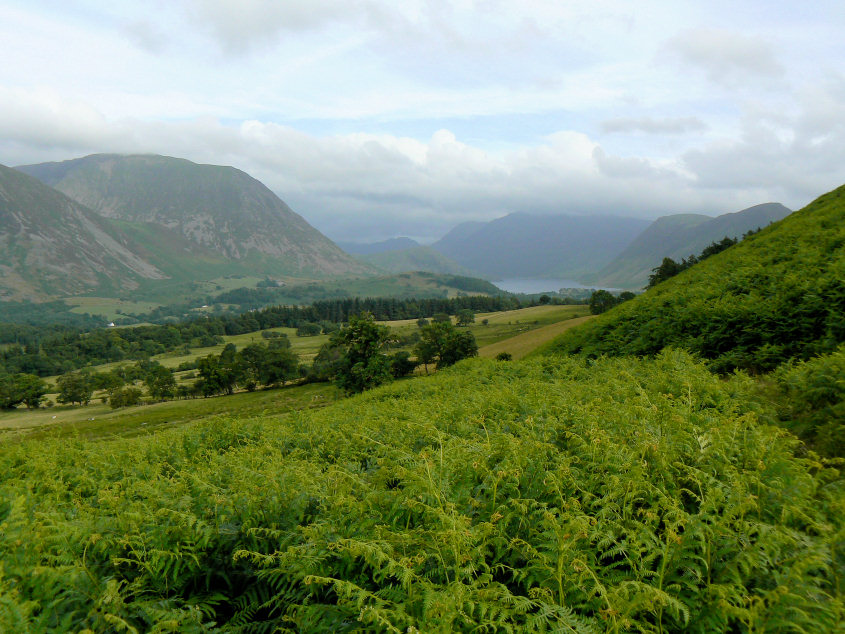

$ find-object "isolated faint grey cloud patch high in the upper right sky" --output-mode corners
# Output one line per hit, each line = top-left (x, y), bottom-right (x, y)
(665, 28), (785, 87)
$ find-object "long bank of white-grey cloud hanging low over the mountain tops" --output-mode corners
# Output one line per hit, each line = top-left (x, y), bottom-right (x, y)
(0, 68), (845, 240)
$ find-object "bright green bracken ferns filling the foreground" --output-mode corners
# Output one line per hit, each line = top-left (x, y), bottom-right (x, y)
(0, 350), (845, 633)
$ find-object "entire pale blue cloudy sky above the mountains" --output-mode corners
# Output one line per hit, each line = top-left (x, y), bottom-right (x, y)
(0, 0), (845, 242)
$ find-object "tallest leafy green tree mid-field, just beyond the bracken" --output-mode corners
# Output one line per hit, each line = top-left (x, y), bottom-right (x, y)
(332, 313), (393, 394)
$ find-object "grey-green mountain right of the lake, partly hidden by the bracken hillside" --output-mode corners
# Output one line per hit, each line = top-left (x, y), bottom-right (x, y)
(588, 203), (792, 289)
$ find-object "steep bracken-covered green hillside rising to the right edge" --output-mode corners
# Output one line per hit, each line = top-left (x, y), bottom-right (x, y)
(548, 186), (845, 371)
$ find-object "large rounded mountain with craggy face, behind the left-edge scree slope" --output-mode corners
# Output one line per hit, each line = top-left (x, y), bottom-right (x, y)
(17, 154), (369, 278)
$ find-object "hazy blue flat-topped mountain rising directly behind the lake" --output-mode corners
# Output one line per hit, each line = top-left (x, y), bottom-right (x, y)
(432, 213), (649, 279)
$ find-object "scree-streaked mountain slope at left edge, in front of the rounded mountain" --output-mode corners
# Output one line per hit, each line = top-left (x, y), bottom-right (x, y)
(0, 165), (167, 300)
